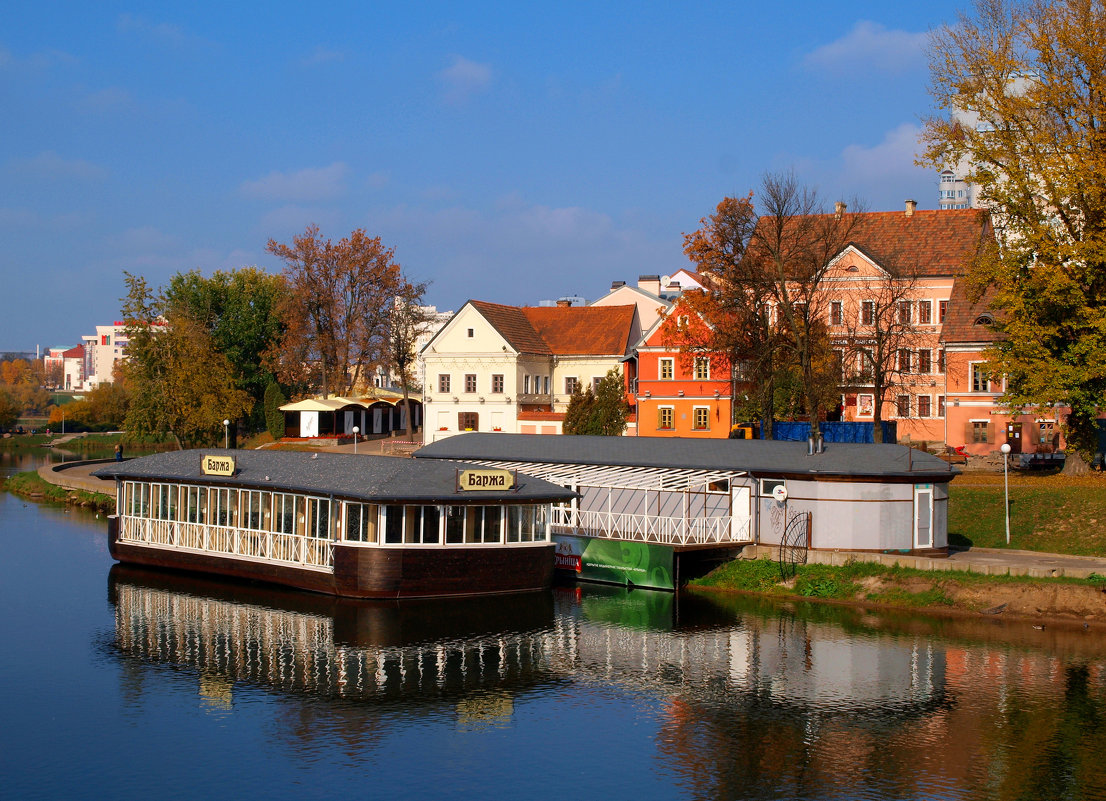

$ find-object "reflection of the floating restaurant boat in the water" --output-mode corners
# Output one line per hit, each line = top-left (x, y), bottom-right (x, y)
(108, 564), (553, 704)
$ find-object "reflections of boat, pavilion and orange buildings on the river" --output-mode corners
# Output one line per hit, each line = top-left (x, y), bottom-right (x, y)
(108, 565), (1106, 799)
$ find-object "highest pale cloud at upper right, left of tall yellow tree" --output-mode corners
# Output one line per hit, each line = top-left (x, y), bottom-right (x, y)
(803, 20), (929, 74)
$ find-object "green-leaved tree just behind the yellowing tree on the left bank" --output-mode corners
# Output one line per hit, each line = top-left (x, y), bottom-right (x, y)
(163, 267), (288, 430)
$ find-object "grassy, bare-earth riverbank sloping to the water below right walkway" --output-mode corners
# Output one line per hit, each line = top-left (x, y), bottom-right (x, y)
(689, 559), (1106, 627)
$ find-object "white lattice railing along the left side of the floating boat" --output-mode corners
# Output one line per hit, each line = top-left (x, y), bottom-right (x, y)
(119, 516), (334, 570)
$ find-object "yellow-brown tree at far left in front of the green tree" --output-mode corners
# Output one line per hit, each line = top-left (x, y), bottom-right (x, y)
(123, 273), (252, 448)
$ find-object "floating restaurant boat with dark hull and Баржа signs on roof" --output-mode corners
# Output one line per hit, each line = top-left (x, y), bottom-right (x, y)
(94, 449), (575, 599)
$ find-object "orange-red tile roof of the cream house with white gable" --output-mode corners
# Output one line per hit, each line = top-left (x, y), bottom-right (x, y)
(469, 301), (636, 356)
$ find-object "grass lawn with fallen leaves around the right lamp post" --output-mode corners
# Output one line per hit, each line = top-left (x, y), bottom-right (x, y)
(949, 472), (1106, 555)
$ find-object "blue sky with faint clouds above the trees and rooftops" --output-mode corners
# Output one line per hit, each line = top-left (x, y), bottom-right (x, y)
(0, 0), (962, 351)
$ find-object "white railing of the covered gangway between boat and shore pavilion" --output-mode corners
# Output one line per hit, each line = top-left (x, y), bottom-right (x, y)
(553, 507), (749, 545)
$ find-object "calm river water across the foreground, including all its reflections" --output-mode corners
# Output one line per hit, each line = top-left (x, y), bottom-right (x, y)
(0, 456), (1106, 799)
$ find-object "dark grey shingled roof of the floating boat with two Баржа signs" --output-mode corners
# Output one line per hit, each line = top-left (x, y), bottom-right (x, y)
(93, 448), (575, 504)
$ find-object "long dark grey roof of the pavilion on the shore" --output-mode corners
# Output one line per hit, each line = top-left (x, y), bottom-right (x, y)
(415, 433), (959, 481)
